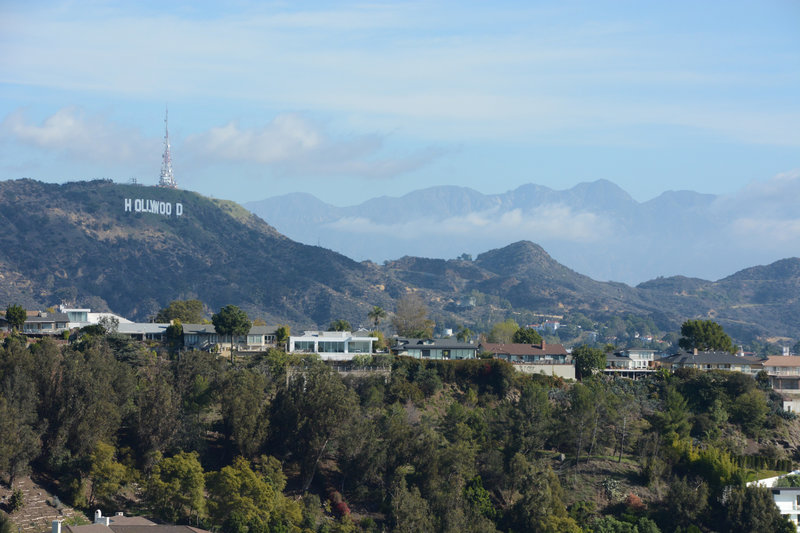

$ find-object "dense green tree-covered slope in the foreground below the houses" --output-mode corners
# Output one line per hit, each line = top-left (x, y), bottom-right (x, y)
(0, 334), (797, 533)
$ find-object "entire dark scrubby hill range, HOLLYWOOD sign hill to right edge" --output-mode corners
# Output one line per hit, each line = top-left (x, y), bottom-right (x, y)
(0, 179), (800, 341)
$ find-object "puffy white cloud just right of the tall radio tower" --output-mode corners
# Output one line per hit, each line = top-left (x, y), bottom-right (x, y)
(184, 113), (441, 178)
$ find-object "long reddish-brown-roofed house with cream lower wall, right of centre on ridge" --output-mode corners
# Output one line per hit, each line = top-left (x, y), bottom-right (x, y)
(479, 340), (575, 379)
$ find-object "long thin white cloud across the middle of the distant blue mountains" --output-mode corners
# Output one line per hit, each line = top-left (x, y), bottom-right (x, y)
(327, 205), (612, 243)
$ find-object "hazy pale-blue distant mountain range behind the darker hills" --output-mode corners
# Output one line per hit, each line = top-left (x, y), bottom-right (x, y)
(244, 174), (800, 285)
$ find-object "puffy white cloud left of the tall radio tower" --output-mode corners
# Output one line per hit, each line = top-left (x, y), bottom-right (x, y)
(0, 107), (159, 163)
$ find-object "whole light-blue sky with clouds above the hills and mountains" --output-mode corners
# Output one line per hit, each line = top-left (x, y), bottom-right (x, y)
(0, 0), (800, 205)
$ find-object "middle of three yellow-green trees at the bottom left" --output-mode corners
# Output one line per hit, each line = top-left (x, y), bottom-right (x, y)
(146, 452), (205, 522)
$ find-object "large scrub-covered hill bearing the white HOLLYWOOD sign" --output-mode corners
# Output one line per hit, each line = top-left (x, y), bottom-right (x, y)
(0, 180), (388, 323)
